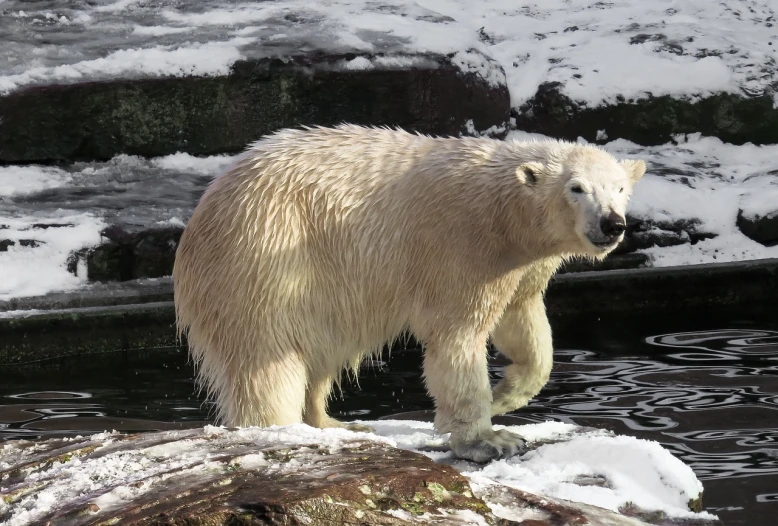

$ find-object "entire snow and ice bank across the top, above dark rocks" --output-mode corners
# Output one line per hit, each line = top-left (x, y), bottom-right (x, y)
(0, 0), (778, 106)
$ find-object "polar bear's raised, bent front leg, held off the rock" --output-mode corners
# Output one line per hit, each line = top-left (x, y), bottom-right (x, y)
(491, 293), (554, 415)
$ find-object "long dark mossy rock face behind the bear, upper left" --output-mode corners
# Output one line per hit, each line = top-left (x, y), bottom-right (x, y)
(0, 53), (510, 163)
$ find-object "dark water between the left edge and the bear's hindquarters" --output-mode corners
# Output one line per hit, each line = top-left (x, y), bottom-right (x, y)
(0, 349), (212, 440)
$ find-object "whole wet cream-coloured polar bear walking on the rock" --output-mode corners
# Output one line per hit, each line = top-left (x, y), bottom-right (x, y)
(173, 125), (645, 461)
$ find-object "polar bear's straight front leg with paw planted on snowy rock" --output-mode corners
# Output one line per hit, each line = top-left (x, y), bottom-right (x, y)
(424, 336), (525, 462)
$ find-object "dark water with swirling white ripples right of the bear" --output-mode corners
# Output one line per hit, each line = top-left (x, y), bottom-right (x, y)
(506, 330), (778, 486)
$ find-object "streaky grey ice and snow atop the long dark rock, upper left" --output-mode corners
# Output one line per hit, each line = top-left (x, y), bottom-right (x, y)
(0, 0), (505, 94)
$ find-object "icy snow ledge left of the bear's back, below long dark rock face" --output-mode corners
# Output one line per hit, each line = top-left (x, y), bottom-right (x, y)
(0, 153), (234, 300)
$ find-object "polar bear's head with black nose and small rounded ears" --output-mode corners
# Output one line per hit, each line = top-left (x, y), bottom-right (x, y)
(517, 143), (646, 259)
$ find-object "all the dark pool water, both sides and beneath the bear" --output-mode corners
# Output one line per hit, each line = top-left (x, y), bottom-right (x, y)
(0, 316), (778, 526)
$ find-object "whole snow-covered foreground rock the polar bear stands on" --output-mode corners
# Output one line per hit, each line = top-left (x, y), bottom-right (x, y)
(0, 420), (716, 526)
